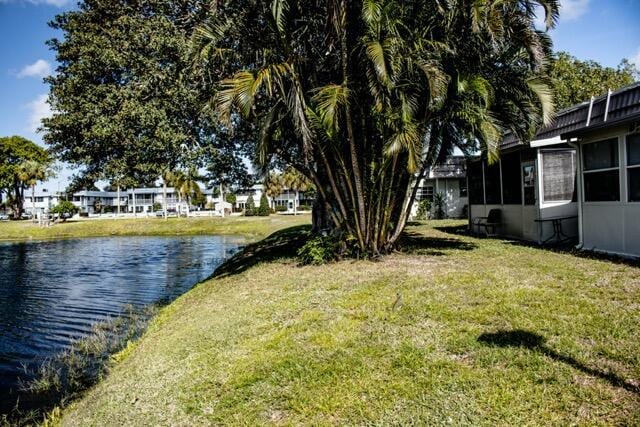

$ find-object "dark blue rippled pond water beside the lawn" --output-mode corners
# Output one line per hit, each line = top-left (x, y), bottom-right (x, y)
(0, 236), (242, 412)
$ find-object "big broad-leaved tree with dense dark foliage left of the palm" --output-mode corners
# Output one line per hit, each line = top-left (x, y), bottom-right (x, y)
(44, 0), (250, 186)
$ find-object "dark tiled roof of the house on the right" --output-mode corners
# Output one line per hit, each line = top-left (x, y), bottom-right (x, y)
(500, 82), (640, 150)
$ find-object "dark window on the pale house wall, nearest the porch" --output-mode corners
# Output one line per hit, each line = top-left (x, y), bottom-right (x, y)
(582, 138), (620, 202)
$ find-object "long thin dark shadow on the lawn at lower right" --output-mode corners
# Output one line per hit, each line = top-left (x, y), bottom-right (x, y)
(478, 329), (640, 394)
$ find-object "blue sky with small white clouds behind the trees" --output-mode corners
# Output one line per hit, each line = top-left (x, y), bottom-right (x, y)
(0, 0), (640, 190)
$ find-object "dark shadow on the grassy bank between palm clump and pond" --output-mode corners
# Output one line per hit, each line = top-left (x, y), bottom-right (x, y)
(211, 225), (311, 277)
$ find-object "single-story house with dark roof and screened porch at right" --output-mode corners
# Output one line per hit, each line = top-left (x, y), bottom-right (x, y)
(467, 83), (640, 256)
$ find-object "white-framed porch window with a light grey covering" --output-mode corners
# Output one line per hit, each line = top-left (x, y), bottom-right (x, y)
(542, 151), (576, 202)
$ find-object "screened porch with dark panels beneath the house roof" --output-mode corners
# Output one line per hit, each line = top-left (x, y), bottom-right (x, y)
(467, 145), (578, 243)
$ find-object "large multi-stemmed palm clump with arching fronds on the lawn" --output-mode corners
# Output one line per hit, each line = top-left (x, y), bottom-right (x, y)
(193, 0), (559, 256)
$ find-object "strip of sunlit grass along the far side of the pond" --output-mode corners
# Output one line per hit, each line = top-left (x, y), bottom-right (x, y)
(0, 215), (311, 241)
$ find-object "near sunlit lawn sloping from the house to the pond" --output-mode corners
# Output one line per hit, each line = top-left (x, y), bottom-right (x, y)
(62, 222), (640, 425)
